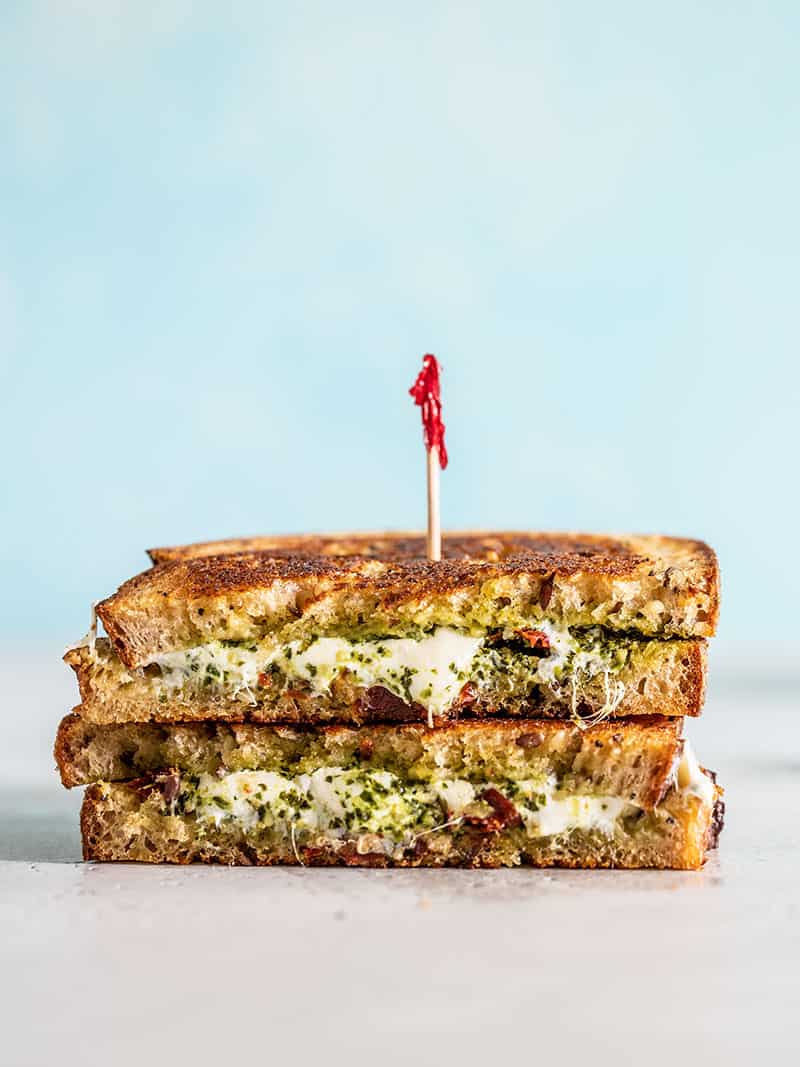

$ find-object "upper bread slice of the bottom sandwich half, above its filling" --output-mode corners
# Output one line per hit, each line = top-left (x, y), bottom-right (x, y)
(55, 714), (683, 809)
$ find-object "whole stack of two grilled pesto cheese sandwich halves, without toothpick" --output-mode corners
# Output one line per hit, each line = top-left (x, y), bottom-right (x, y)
(55, 534), (722, 869)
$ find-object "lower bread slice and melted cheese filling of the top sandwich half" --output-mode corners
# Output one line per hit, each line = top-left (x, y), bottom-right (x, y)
(65, 623), (706, 724)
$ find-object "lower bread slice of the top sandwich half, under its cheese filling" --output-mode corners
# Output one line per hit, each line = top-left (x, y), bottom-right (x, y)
(64, 638), (706, 723)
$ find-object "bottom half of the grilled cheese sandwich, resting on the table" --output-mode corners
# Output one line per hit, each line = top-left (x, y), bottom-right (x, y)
(61, 715), (723, 869)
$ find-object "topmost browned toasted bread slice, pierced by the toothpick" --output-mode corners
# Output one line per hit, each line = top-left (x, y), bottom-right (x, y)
(97, 532), (719, 667)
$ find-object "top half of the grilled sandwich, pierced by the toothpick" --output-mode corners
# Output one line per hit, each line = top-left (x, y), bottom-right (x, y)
(67, 532), (719, 721)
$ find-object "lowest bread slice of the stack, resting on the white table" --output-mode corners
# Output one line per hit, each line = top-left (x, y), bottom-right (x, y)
(81, 784), (722, 870)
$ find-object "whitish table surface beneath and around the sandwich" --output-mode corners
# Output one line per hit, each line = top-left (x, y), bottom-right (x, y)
(0, 654), (800, 1067)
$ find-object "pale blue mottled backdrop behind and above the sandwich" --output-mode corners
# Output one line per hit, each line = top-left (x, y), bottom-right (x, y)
(0, 0), (800, 642)
